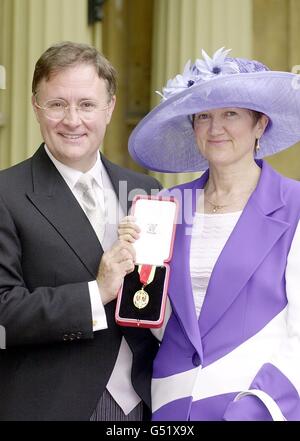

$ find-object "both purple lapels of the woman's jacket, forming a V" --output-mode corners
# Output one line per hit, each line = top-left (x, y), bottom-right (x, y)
(169, 161), (289, 346)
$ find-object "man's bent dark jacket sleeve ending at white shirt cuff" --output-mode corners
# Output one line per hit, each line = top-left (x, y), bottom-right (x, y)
(0, 199), (93, 349)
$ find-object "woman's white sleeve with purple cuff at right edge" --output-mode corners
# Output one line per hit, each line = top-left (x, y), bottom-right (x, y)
(224, 223), (300, 421)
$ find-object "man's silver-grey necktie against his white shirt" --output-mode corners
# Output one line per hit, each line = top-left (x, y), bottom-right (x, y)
(76, 173), (105, 242)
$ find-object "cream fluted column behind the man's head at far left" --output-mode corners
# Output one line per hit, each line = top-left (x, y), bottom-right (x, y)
(0, 0), (93, 168)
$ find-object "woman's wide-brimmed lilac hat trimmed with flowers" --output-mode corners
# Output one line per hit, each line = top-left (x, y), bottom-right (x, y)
(129, 48), (300, 173)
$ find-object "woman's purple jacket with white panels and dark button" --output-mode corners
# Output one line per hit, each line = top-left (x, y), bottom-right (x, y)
(152, 161), (300, 421)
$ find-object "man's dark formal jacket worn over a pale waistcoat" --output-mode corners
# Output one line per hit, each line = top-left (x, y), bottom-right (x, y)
(0, 145), (159, 421)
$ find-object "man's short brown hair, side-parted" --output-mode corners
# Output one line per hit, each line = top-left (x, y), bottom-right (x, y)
(32, 41), (117, 99)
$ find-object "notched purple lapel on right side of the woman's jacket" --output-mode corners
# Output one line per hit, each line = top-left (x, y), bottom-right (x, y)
(199, 162), (289, 338)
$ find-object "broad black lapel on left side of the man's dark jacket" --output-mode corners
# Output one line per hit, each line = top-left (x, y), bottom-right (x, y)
(27, 146), (103, 278)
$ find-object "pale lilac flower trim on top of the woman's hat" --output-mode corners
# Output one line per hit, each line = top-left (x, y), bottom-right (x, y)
(156, 47), (269, 101)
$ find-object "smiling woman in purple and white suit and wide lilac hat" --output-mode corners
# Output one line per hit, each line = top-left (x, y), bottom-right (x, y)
(120, 48), (300, 421)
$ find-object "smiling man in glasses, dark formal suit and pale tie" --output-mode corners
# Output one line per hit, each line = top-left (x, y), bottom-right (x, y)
(0, 42), (160, 421)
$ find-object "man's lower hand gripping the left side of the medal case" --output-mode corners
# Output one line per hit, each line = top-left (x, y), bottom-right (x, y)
(97, 241), (135, 305)
